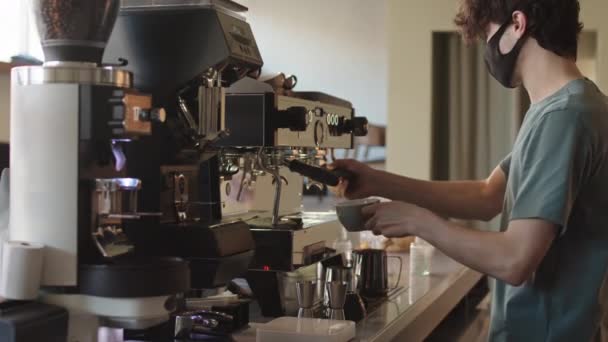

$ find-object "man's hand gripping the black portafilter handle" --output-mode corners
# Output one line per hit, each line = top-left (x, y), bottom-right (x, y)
(329, 159), (380, 199)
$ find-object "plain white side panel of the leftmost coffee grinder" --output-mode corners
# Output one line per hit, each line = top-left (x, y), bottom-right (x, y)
(10, 83), (79, 286)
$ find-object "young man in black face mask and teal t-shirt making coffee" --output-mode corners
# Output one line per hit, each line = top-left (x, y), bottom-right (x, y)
(333, 0), (608, 341)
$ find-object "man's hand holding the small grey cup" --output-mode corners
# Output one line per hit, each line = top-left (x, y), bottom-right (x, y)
(362, 202), (441, 238)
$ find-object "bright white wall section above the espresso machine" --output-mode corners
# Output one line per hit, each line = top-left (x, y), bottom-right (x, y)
(245, 0), (388, 124)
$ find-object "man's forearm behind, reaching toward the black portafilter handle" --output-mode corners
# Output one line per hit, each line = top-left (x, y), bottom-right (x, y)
(374, 172), (502, 220)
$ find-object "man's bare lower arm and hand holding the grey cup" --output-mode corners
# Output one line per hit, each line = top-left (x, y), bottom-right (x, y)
(362, 202), (558, 286)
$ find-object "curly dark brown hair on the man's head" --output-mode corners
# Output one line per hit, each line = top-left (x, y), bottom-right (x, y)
(454, 0), (583, 58)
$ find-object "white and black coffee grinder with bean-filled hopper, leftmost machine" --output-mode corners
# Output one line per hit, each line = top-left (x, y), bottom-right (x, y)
(5, 0), (190, 341)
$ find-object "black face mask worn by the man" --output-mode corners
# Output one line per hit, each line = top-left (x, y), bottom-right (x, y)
(485, 20), (527, 88)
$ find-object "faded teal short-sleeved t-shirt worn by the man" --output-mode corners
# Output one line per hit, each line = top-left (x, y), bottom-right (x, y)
(490, 79), (608, 342)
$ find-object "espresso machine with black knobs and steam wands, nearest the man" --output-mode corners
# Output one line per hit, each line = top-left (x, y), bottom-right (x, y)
(216, 74), (367, 317)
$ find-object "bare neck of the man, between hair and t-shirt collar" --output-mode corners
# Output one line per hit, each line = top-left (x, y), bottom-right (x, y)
(521, 47), (584, 103)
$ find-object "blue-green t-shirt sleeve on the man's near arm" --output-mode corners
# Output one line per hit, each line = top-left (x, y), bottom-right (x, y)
(510, 111), (590, 234)
